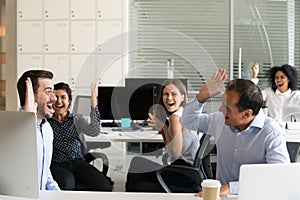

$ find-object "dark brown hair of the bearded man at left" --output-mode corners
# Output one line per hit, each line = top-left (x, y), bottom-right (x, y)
(17, 70), (53, 106)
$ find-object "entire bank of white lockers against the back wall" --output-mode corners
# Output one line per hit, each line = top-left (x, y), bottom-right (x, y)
(17, 0), (126, 87)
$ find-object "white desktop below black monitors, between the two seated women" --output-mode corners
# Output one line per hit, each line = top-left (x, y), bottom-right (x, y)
(85, 128), (163, 142)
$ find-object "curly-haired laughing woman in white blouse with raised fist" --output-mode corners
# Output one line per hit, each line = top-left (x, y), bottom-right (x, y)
(252, 64), (300, 126)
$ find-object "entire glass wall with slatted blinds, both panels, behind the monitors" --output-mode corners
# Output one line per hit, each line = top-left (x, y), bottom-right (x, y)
(127, 0), (300, 102)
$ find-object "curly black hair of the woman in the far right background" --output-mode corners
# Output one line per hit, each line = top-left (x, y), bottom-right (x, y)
(269, 64), (298, 92)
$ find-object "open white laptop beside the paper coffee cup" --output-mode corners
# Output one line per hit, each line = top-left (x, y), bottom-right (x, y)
(237, 163), (300, 200)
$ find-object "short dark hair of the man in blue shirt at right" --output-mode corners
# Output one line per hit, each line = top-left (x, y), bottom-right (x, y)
(226, 79), (263, 115)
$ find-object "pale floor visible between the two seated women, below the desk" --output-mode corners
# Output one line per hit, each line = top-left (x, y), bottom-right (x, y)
(94, 142), (162, 192)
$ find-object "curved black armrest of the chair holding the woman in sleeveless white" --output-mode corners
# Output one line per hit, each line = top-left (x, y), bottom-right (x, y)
(156, 165), (204, 193)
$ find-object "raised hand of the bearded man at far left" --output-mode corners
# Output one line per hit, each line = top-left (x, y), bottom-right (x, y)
(23, 77), (37, 114)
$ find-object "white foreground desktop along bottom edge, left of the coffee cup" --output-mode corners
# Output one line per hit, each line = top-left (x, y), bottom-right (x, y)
(0, 191), (202, 200)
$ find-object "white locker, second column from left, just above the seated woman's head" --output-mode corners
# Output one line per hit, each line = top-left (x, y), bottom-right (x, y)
(44, 54), (70, 83)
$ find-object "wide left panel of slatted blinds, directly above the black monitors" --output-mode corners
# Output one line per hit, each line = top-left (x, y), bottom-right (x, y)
(129, 0), (229, 101)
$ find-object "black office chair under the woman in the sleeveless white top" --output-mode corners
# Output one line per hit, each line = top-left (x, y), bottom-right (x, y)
(156, 134), (215, 193)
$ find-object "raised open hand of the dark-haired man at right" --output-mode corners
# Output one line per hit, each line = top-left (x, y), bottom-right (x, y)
(197, 69), (227, 103)
